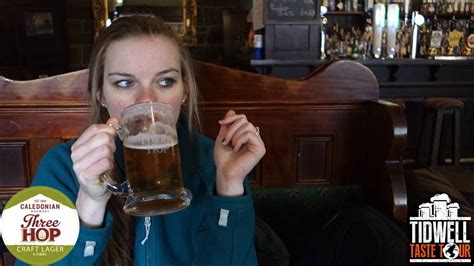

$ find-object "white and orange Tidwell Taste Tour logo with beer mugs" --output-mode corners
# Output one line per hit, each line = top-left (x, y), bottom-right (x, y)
(410, 193), (471, 263)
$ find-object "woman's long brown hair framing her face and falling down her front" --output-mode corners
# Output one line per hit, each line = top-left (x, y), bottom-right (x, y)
(88, 15), (199, 265)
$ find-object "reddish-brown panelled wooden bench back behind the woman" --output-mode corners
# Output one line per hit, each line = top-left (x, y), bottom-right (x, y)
(0, 61), (407, 264)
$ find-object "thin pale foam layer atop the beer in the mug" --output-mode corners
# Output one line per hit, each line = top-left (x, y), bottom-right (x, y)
(123, 133), (178, 150)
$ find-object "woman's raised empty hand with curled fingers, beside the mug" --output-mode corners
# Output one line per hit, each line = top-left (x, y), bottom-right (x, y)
(214, 110), (265, 196)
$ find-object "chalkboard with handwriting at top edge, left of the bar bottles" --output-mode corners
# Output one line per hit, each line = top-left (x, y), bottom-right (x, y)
(265, 0), (320, 24)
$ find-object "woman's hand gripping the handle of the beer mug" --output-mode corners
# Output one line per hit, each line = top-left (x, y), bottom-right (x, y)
(71, 118), (118, 227)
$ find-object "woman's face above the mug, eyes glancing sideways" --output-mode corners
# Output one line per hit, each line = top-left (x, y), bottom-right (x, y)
(102, 36), (186, 121)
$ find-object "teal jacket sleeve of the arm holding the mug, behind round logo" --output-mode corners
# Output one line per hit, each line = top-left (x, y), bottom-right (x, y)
(15, 143), (113, 265)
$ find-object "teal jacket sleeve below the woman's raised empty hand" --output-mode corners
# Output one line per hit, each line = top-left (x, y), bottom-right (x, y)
(193, 137), (258, 266)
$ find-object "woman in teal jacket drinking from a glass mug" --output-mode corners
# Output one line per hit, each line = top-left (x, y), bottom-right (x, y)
(18, 16), (265, 265)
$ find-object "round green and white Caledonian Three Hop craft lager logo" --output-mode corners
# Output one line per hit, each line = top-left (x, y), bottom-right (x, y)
(2, 187), (79, 264)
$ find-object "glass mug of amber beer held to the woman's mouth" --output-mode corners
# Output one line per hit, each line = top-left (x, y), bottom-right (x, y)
(100, 102), (192, 216)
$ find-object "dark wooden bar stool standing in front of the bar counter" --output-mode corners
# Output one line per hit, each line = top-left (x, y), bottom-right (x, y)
(416, 98), (464, 166)
